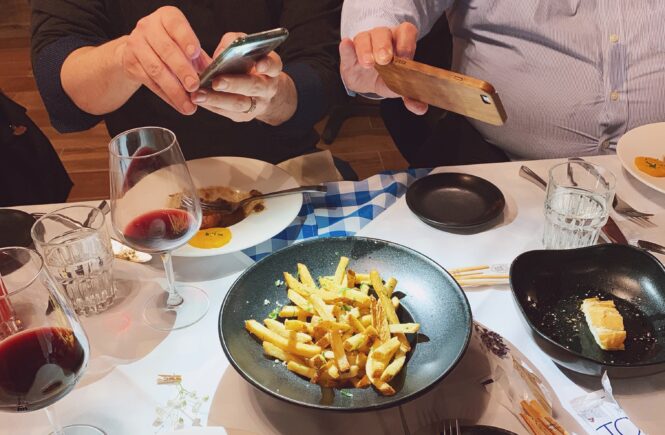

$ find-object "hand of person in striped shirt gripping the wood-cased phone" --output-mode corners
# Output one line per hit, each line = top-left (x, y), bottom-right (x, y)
(339, 23), (427, 115)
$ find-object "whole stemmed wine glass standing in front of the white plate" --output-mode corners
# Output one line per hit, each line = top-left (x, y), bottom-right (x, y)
(109, 127), (210, 331)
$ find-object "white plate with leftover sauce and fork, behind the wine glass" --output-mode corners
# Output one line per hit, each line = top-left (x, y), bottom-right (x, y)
(173, 157), (302, 257)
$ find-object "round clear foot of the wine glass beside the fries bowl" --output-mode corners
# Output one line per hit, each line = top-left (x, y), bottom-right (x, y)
(143, 285), (210, 331)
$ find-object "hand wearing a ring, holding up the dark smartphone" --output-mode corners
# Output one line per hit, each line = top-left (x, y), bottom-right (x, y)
(191, 32), (297, 125)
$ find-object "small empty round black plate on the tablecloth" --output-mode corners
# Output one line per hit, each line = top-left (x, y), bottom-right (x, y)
(406, 172), (506, 230)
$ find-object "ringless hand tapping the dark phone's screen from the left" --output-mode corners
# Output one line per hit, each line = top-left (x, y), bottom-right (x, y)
(120, 6), (202, 115)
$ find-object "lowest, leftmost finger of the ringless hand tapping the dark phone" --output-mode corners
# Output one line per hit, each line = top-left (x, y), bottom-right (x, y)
(134, 34), (196, 115)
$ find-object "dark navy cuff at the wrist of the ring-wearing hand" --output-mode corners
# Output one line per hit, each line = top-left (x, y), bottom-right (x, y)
(280, 63), (330, 128)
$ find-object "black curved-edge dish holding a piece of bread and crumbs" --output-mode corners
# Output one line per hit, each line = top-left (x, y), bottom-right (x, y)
(510, 245), (665, 377)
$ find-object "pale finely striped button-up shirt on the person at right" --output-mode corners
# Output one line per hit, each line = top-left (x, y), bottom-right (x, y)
(342, 0), (665, 159)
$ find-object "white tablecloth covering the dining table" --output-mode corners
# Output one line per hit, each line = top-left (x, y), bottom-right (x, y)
(0, 156), (665, 435)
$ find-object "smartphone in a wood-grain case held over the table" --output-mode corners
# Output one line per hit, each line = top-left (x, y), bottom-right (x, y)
(375, 57), (506, 125)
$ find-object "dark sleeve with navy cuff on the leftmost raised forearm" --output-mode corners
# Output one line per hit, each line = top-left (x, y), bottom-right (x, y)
(31, 0), (110, 133)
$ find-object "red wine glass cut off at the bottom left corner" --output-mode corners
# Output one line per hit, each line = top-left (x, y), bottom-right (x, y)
(0, 247), (104, 435)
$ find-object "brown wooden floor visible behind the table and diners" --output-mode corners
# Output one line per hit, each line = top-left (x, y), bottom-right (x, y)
(0, 0), (406, 201)
